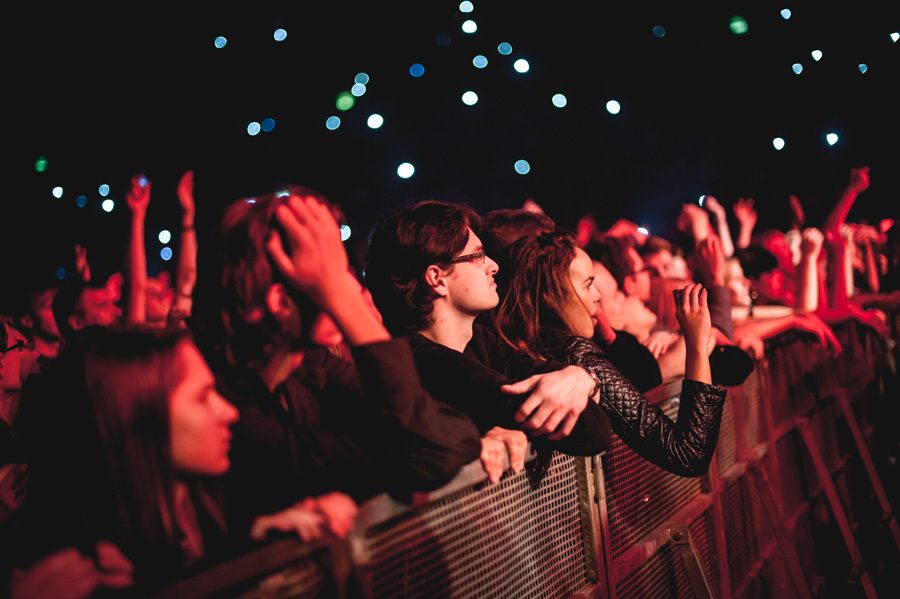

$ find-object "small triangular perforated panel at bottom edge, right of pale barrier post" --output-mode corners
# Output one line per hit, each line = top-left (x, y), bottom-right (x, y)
(616, 543), (695, 599)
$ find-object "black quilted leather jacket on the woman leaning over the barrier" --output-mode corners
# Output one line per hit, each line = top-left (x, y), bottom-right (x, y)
(542, 328), (726, 476)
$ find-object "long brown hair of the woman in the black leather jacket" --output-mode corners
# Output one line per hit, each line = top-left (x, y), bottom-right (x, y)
(494, 231), (577, 358)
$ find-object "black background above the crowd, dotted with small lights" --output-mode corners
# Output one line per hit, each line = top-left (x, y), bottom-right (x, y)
(7, 0), (900, 276)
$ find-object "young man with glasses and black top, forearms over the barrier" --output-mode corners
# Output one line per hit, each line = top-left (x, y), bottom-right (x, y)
(366, 200), (610, 455)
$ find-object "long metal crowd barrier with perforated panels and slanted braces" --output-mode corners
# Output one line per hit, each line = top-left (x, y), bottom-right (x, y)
(158, 304), (900, 599)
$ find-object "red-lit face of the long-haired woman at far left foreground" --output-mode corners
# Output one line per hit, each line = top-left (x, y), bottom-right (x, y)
(169, 341), (238, 476)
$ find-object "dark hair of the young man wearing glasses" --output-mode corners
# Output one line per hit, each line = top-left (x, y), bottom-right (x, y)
(365, 200), (480, 335)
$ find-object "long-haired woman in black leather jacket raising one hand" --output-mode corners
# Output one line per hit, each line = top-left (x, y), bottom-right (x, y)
(488, 232), (726, 476)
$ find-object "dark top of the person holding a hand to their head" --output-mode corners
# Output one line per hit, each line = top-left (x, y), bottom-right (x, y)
(214, 339), (481, 528)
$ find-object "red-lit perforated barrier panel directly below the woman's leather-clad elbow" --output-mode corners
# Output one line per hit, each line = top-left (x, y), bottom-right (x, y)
(603, 400), (701, 558)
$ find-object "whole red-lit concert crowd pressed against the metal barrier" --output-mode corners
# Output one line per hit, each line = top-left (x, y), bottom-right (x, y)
(0, 167), (900, 599)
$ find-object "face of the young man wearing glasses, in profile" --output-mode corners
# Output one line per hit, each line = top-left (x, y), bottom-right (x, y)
(442, 229), (500, 316)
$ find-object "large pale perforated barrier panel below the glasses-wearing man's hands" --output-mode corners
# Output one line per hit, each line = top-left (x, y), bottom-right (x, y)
(363, 454), (591, 598)
